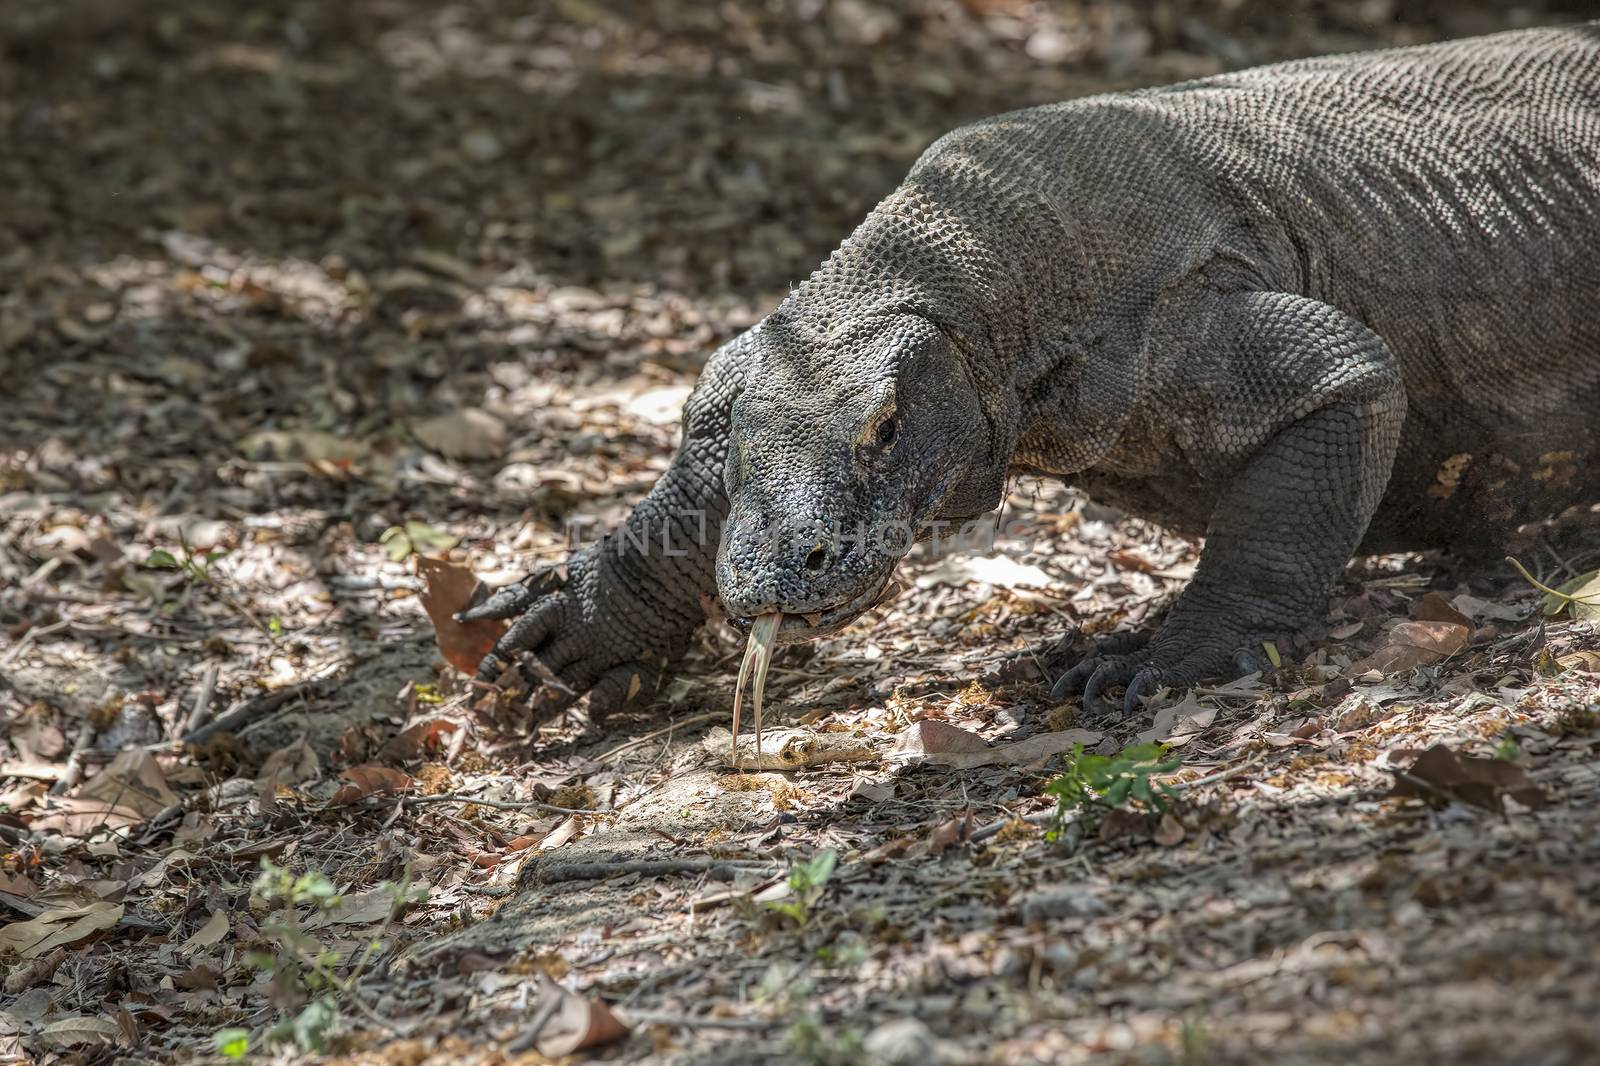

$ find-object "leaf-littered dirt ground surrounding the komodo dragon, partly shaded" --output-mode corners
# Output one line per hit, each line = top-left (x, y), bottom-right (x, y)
(0, 0), (1600, 1066)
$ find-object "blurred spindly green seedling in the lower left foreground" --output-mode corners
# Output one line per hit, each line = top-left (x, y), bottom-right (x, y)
(240, 858), (427, 1055)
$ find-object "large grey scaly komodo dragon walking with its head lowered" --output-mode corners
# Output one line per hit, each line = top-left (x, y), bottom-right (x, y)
(462, 22), (1600, 712)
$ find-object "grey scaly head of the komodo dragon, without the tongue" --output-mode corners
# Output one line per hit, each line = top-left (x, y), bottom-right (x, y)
(717, 307), (1003, 642)
